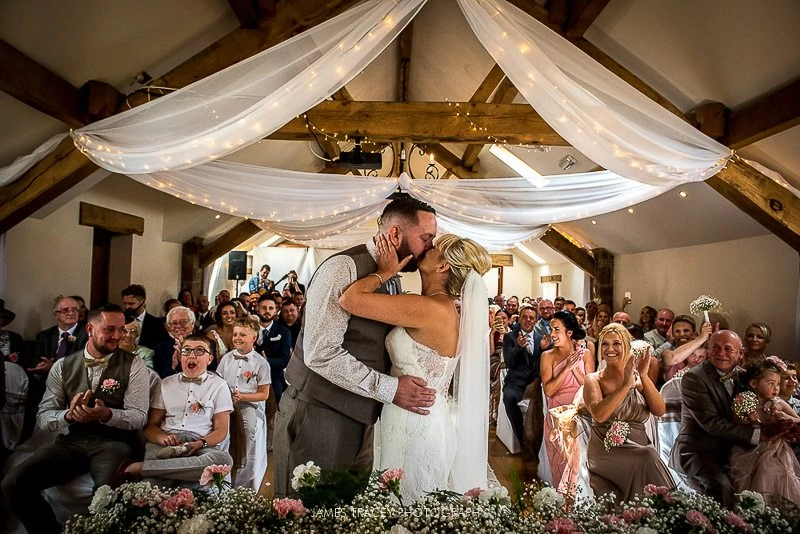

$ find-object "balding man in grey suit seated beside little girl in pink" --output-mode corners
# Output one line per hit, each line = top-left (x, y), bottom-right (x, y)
(670, 330), (792, 507)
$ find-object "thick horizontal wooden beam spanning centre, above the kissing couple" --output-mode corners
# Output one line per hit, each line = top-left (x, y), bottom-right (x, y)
(278, 101), (567, 146)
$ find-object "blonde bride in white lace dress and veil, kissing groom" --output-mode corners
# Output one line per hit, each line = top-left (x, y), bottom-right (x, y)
(339, 234), (492, 502)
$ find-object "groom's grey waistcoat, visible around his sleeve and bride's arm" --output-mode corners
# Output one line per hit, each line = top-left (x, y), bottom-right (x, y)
(286, 245), (392, 424)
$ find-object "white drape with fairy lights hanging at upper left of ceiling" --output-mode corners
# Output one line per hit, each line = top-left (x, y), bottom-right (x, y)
(72, 0), (426, 174)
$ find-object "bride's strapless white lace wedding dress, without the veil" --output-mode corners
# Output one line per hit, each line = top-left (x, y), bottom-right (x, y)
(380, 326), (460, 505)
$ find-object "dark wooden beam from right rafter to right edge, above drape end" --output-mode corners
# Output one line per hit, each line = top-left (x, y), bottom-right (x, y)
(722, 79), (800, 150)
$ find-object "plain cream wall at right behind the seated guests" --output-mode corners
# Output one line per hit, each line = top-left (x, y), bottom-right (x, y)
(614, 235), (800, 360)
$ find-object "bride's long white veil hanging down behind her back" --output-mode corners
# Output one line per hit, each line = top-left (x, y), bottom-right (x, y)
(450, 271), (489, 493)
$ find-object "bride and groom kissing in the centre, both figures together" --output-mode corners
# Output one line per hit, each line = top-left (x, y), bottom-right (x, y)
(274, 194), (491, 502)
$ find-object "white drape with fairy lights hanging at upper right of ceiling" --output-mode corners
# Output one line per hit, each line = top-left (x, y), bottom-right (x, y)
(458, 0), (732, 185)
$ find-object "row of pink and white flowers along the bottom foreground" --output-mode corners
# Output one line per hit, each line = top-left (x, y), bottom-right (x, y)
(64, 464), (798, 534)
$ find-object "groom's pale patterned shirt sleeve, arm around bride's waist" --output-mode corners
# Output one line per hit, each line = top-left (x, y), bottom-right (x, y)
(303, 256), (398, 404)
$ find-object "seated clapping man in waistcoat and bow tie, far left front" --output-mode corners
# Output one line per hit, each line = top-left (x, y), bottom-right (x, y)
(2, 305), (150, 534)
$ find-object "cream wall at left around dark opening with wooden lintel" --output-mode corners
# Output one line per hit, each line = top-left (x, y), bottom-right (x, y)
(0, 175), (182, 339)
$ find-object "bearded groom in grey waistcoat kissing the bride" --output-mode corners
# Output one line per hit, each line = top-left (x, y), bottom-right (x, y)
(274, 194), (436, 496)
